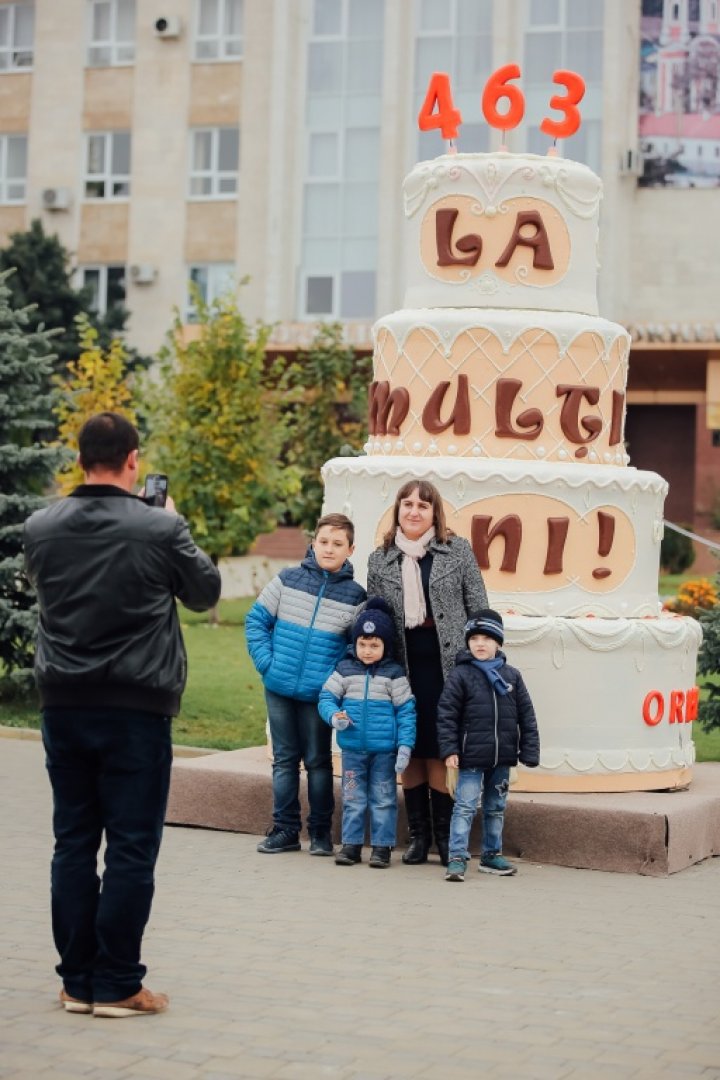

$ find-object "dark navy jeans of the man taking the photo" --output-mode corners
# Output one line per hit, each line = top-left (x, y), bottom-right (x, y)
(42, 708), (173, 1001)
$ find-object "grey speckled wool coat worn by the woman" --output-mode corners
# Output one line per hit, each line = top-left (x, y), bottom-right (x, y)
(367, 536), (488, 678)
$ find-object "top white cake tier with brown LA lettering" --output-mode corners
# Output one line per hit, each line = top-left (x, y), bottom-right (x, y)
(403, 152), (602, 315)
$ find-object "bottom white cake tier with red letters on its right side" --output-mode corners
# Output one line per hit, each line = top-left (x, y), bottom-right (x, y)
(504, 615), (702, 792)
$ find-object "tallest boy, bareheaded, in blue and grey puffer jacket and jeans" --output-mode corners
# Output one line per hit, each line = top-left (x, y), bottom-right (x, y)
(245, 514), (365, 855)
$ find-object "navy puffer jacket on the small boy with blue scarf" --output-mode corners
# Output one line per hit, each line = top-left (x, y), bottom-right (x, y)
(437, 649), (540, 769)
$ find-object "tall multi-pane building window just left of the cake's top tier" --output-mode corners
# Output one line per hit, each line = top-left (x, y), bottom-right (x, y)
(298, 0), (385, 319)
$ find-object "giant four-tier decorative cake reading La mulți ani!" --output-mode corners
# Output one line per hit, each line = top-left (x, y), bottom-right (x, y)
(323, 152), (701, 792)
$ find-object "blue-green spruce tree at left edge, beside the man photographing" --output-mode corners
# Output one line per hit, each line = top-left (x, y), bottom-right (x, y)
(0, 271), (58, 691)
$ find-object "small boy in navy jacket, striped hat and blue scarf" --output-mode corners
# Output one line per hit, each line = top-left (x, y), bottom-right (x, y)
(437, 608), (540, 881)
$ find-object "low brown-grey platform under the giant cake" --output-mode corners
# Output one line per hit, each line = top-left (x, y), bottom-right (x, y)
(167, 746), (720, 877)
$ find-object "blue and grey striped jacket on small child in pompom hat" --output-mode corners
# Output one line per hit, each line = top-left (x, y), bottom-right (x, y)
(317, 657), (416, 753)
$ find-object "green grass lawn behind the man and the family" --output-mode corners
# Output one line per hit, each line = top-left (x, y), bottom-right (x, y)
(0, 596), (720, 761)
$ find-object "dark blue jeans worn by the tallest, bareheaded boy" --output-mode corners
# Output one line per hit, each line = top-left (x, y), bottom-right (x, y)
(264, 689), (335, 835)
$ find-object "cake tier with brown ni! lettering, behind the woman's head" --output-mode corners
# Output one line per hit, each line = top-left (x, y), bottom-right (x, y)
(323, 456), (667, 618)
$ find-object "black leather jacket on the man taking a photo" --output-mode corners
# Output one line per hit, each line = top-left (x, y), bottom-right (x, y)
(25, 484), (220, 716)
